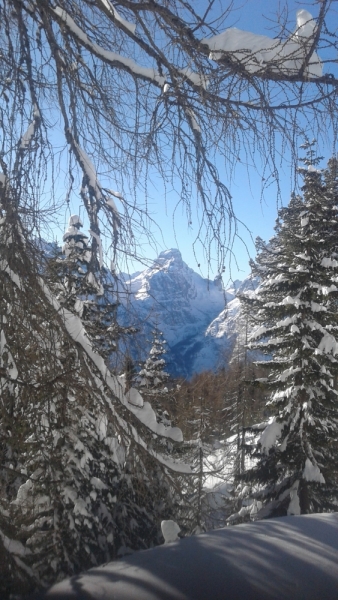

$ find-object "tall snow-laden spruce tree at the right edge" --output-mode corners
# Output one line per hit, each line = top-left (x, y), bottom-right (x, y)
(240, 149), (338, 518)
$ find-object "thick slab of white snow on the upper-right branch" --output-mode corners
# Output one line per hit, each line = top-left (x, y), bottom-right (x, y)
(201, 10), (323, 77)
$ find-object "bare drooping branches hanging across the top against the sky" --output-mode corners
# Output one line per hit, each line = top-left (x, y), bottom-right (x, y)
(0, 0), (337, 263)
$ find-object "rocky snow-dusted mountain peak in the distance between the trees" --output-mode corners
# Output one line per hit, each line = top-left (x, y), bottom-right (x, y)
(120, 249), (256, 376)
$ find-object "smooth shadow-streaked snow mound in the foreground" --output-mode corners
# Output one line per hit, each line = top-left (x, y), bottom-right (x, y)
(33, 514), (338, 600)
